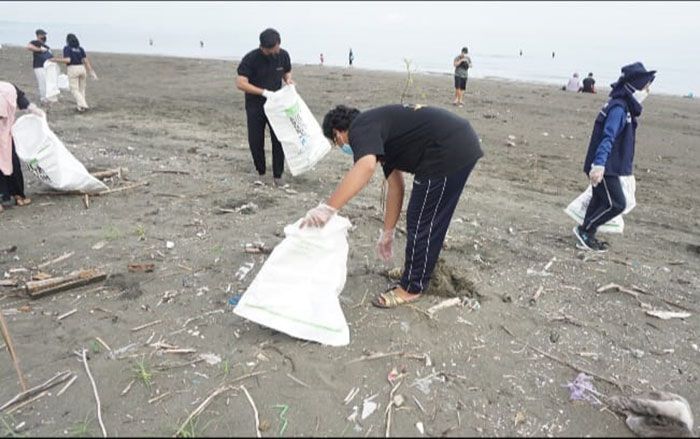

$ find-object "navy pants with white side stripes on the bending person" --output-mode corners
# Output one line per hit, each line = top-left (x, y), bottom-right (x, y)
(400, 163), (476, 293)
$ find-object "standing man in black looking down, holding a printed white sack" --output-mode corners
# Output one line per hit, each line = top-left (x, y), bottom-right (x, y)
(236, 28), (293, 186)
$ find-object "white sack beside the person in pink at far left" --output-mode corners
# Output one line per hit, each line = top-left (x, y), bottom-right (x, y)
(12, 114), (109, 193)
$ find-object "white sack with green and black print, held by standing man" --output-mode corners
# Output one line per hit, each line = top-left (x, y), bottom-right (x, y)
(264, 85), (331, 175)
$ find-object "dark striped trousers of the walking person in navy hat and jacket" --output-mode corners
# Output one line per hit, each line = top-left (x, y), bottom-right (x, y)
(582, 175), (627, 236)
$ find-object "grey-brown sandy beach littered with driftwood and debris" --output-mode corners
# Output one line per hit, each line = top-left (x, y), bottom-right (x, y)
(0, 47), (700, 437)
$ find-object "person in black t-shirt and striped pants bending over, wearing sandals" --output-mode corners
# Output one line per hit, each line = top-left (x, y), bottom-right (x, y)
(301, 104), (483, 308)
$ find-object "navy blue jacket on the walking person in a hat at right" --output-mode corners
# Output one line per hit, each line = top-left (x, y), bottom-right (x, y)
(583, 98), (637, 176)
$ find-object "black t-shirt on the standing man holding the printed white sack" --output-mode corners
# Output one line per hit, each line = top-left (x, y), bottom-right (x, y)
(238, 49), (292, 107)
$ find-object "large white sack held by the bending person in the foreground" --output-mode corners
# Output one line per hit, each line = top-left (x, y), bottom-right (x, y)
(233, 215), (350, 346)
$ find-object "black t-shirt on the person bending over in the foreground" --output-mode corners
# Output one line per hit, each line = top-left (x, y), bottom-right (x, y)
(349, 104), (484, 178)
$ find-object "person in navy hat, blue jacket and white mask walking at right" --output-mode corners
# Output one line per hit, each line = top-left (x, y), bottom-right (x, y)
(574, 62), (656, 252)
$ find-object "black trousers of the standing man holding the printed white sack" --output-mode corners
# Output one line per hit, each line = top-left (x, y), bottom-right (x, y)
(245, 105), (284, 178)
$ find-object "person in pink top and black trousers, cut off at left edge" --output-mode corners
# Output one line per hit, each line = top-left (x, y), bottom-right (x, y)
(0, 81), (46, 213)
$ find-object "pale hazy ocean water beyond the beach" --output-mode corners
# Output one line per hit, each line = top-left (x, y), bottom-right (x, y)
(0, 16), (700, 96)
